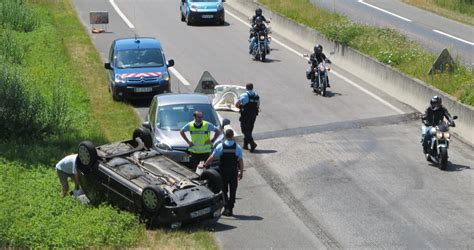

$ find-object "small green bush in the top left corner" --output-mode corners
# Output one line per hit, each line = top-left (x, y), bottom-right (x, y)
(0, 0), (39, 32)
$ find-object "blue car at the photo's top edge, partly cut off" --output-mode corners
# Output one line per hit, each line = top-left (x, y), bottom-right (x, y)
(179, 0), (225, 25)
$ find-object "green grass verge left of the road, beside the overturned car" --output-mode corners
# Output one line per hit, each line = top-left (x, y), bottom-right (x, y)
(0, 0), (216, 249)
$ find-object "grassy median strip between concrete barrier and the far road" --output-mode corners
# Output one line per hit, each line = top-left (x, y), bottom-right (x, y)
(259, 0), (474, 106)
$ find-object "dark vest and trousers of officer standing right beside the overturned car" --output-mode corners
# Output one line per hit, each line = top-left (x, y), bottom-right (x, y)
(219, 143), (239, 209)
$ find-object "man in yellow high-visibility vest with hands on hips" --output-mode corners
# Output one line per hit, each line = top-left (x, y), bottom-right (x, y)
(179, 111), (221, 171)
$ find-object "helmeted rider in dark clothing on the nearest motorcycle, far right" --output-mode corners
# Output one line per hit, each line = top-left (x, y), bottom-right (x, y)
(421, 95), (456, 155)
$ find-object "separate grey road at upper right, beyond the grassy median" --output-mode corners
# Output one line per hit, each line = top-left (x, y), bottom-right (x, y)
(311, 0), (474, 67)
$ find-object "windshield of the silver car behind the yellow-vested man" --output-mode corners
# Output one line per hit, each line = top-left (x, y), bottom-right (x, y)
(157, 104), (220, 130)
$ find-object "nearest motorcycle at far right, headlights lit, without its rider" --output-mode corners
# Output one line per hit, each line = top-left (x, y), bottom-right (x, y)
(426, 116), (458, 170)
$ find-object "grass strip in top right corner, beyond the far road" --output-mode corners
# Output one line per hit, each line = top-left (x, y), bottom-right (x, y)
(402, 0), (474, 25)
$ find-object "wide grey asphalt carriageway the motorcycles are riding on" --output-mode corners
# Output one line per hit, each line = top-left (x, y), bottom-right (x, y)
(74, 0), (474, 249)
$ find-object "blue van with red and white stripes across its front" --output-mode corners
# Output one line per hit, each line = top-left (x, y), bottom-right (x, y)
(104, 38), (174, 101)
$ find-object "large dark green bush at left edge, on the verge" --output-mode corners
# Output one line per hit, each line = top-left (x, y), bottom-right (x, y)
(0, 65), (69, 140)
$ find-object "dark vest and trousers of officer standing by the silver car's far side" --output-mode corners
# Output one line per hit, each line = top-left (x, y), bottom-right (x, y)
(240, 92), (260, 146)
